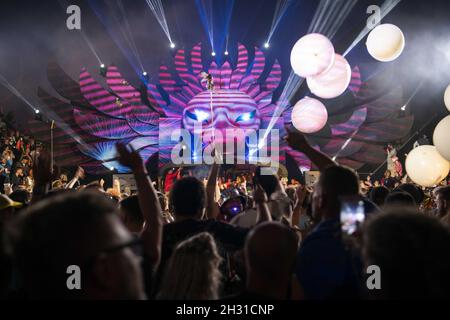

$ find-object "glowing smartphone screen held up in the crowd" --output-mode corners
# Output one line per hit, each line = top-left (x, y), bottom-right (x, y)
(341, 198), (366, 235)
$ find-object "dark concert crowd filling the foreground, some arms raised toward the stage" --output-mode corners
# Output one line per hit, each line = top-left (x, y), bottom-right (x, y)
(0, 120), (450, 300)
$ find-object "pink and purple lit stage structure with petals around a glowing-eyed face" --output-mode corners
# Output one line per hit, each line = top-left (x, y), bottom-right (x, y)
(30, 44), (413, 174)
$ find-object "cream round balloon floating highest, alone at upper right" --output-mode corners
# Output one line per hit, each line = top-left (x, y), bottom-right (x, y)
(366, 23), (405, 62)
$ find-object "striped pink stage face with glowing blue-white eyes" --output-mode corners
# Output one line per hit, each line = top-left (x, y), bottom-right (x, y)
(183, 89), (261, 141)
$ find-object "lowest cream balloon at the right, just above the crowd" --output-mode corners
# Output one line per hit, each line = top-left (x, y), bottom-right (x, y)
(405, 145), (450, 187)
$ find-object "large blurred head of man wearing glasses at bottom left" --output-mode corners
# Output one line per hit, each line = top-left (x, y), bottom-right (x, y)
(15, 191), (145, 299)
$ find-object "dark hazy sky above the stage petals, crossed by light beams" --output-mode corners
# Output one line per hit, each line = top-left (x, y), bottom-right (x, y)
(0, 0), (450, 172)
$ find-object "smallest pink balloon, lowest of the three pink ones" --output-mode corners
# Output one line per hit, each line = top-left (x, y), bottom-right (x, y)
(291, 97), (328, 133)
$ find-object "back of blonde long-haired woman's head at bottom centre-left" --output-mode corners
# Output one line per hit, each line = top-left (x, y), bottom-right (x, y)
(157, 232), (222, 300)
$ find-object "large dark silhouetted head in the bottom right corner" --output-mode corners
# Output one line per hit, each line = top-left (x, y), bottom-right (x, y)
(363, 208), (450, 299)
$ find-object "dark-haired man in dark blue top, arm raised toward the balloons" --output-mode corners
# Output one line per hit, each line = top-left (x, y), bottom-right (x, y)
(287, 131), (360, 299)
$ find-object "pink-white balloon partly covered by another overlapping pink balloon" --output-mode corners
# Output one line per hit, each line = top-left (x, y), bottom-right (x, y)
(306, 54), (352, 99)
